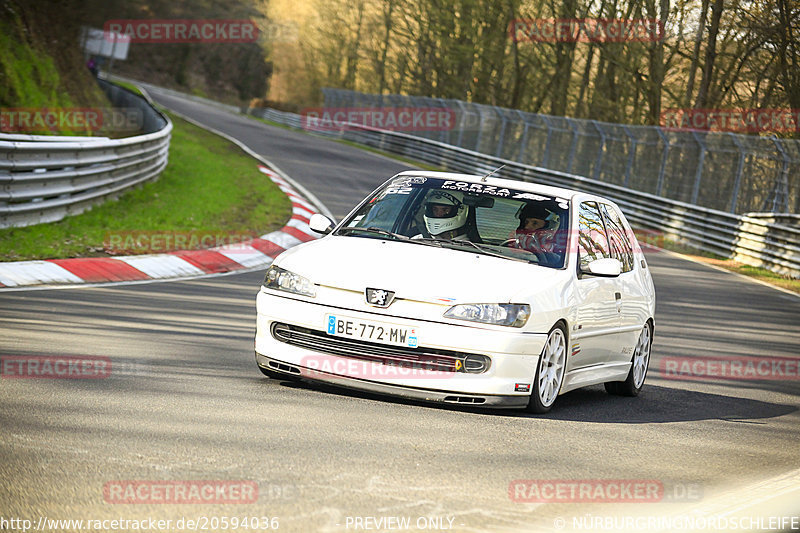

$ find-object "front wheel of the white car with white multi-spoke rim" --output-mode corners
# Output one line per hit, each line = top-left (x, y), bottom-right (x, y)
(528, 325), (567, 414)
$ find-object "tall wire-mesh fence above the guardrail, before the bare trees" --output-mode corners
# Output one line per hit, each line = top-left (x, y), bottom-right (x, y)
(322, 88), (800, 214)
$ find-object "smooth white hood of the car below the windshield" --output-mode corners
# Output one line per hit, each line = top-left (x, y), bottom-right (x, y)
(276, 236), (562, 303)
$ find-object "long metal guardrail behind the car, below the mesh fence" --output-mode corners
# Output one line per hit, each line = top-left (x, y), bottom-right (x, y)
(249, 109), (800, 277)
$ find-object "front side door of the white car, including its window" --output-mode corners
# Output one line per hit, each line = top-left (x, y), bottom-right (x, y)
(571, 197), (622, 369)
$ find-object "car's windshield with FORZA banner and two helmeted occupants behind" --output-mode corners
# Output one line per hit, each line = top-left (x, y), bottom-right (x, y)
(337, 176), (569, 268)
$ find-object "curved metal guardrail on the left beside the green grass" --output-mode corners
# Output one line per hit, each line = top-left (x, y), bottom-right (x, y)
(0, 80), (172, 228)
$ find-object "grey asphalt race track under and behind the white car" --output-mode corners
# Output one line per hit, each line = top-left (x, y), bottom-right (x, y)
(0, 88), (800, 531)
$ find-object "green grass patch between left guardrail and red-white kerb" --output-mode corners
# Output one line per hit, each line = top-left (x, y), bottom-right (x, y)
(0, 116), (291, 261)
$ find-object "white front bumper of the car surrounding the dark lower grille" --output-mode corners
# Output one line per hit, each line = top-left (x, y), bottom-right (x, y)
(255, 290), (547, 408)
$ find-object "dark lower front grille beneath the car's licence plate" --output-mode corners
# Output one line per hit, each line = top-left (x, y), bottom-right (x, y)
(272, 322), (491, 374)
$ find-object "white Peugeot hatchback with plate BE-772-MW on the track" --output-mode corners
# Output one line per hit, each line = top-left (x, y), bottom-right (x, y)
(255, 171), (655, 413)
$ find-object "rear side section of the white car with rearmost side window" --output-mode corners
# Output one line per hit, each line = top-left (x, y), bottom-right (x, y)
(600, 203), (648, 362)
